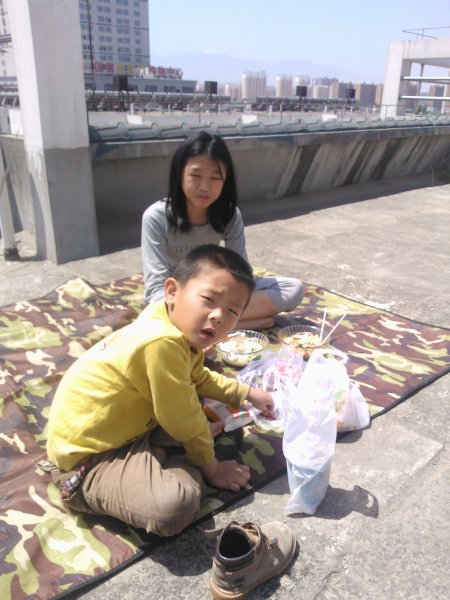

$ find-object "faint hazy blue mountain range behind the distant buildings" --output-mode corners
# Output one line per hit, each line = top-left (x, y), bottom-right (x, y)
(151, 52), (368, 85)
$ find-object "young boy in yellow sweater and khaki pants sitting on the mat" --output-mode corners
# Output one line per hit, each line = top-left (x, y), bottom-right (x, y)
(47, 245), (273, 536)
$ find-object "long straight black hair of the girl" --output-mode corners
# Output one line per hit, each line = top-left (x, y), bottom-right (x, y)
(166, 131), (237, 232)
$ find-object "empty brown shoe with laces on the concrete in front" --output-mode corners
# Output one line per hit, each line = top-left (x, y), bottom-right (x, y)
(210, 521), (297, 600)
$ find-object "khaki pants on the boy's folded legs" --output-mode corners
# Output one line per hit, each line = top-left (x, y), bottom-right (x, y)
(52, 433), (206, 537)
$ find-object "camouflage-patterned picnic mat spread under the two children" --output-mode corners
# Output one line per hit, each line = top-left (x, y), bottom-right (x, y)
(0, 275), (450, 600)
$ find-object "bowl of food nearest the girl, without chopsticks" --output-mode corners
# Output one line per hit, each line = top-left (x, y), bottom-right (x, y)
(216, 329), (269, 367)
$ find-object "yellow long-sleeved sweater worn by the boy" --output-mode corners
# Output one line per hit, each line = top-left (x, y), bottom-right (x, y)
(47, 302), (249, 471)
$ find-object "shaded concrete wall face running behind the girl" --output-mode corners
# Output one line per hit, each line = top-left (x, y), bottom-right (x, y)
(91, 125), (450, 219)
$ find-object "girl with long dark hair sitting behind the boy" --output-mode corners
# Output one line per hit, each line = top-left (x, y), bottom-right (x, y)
(142, 131), (303, 329)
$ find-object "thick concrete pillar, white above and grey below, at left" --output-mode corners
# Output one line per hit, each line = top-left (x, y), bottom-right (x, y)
(9, 0), (99, 263)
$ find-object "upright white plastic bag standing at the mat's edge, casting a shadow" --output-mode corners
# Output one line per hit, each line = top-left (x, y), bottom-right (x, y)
(283, 350), (347, 515)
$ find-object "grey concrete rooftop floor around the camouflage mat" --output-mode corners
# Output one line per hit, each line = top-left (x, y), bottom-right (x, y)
(0, 174), (450, 600)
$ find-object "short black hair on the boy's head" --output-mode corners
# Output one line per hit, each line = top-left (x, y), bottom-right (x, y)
(173, 244), (255, 297)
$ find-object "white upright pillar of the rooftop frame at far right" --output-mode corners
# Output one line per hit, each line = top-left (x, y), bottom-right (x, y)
(381, 42), (412, 117)
